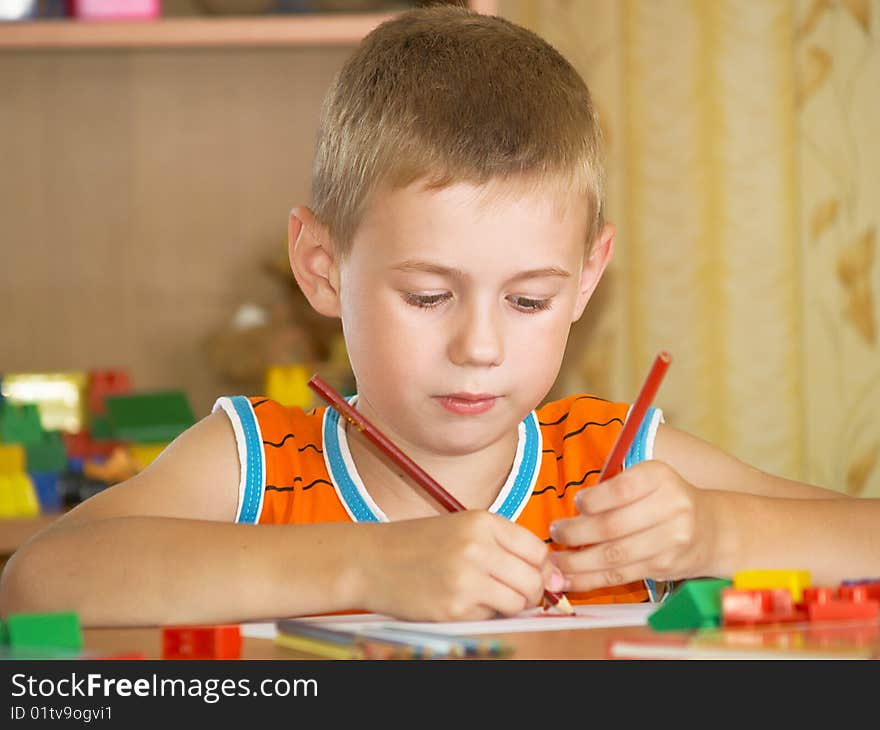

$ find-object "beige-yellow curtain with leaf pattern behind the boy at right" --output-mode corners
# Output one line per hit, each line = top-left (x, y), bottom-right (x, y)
(500, 0), (880, 496)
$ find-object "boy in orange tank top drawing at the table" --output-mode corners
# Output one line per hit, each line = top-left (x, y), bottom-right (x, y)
(0, 6), (880, 626)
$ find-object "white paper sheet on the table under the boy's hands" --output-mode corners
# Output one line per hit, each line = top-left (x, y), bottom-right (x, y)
(241, 603), (658, 639)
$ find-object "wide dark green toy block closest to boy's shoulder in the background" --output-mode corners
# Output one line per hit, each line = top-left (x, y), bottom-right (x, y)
(104, 390), (195, 444)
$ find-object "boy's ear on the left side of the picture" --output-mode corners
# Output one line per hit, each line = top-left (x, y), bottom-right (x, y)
(287, 206), (339, 317)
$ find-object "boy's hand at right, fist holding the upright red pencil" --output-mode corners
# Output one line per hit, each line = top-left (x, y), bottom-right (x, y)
(550, 461), (714, 591)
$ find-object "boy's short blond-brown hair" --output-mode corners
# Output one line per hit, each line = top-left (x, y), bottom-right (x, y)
(312, 5), (603, 256)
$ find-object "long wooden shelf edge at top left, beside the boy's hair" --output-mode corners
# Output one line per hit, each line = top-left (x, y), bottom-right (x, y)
(0, 12), (395, 51)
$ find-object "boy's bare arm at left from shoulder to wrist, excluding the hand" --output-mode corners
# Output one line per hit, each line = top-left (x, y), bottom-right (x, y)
(0, 413), (364, 625)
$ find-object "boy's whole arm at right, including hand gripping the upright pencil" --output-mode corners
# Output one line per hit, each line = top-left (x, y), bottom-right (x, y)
(551, 426), (880, 590)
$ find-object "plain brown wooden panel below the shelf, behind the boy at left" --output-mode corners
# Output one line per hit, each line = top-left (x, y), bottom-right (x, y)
(0, 47), (350, 416)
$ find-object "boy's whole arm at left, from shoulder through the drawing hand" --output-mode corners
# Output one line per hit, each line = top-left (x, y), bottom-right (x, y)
(0, 413), (562, 626)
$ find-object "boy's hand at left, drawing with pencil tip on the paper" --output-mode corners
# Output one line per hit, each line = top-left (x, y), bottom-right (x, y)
(355, 510), (563, 621)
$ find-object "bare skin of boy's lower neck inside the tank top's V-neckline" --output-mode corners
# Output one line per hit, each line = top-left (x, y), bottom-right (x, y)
(345, 416), (518, 520)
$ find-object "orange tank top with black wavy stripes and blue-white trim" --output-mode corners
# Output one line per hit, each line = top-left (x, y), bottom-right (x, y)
(214, 394), (662, 603)
